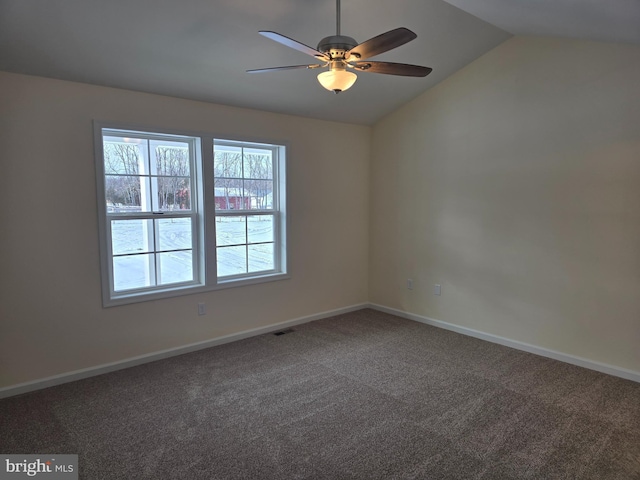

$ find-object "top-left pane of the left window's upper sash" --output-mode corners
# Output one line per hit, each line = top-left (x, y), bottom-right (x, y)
(102, 137), (147, 175)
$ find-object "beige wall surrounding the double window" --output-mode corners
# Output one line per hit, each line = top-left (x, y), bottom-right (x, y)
(0, 73), (370, 387)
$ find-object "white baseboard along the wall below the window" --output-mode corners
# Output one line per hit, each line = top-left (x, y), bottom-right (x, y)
(0, 303), (369, 398)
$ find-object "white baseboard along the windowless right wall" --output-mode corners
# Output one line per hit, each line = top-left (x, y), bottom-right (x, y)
(369, 304), (640, 383)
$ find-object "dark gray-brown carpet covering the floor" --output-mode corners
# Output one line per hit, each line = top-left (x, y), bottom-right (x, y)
(0, 309), (640, 480)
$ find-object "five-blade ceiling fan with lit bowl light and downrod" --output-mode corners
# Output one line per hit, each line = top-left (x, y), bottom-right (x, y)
(247, 0), (432, 93)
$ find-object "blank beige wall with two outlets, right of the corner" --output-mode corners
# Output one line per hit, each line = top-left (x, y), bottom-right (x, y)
(369, 37), (640, 372)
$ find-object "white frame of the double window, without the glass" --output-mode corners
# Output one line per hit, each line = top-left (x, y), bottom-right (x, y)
(94, 121), (290, 307)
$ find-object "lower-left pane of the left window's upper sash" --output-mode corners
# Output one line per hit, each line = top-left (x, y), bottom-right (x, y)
(105, 175), (151, 213)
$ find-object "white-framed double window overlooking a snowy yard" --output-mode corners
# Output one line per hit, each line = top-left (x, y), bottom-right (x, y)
(96, 125), (286, 306)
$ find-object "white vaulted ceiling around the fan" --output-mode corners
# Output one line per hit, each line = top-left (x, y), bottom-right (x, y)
(0, 0), (640, 125)
